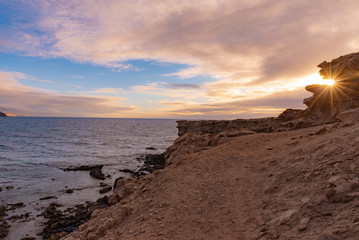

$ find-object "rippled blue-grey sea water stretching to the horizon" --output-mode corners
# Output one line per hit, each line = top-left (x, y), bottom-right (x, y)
(0, 117), (177, 239)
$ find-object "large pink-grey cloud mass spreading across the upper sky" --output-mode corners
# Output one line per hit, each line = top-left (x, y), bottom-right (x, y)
(0, 0), (359, 116)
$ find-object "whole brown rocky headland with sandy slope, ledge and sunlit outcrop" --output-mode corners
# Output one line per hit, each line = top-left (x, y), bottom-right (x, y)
(3, 53), (359, 240)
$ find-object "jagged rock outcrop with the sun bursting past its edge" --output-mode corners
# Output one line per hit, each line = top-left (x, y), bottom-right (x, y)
(304, 53), (359, 120)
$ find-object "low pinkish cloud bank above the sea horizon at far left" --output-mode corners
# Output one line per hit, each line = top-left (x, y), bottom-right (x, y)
(0, 72), (136, 117)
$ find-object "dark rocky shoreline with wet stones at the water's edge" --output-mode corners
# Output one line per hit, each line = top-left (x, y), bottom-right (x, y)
(0, 148), (164, 240)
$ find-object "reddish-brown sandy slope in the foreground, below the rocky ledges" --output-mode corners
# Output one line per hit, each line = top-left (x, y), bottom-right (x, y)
(65, 124), (359, 240)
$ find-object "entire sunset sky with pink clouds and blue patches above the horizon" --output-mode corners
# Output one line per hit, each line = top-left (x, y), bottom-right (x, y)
(0, 0), (359, 119)
